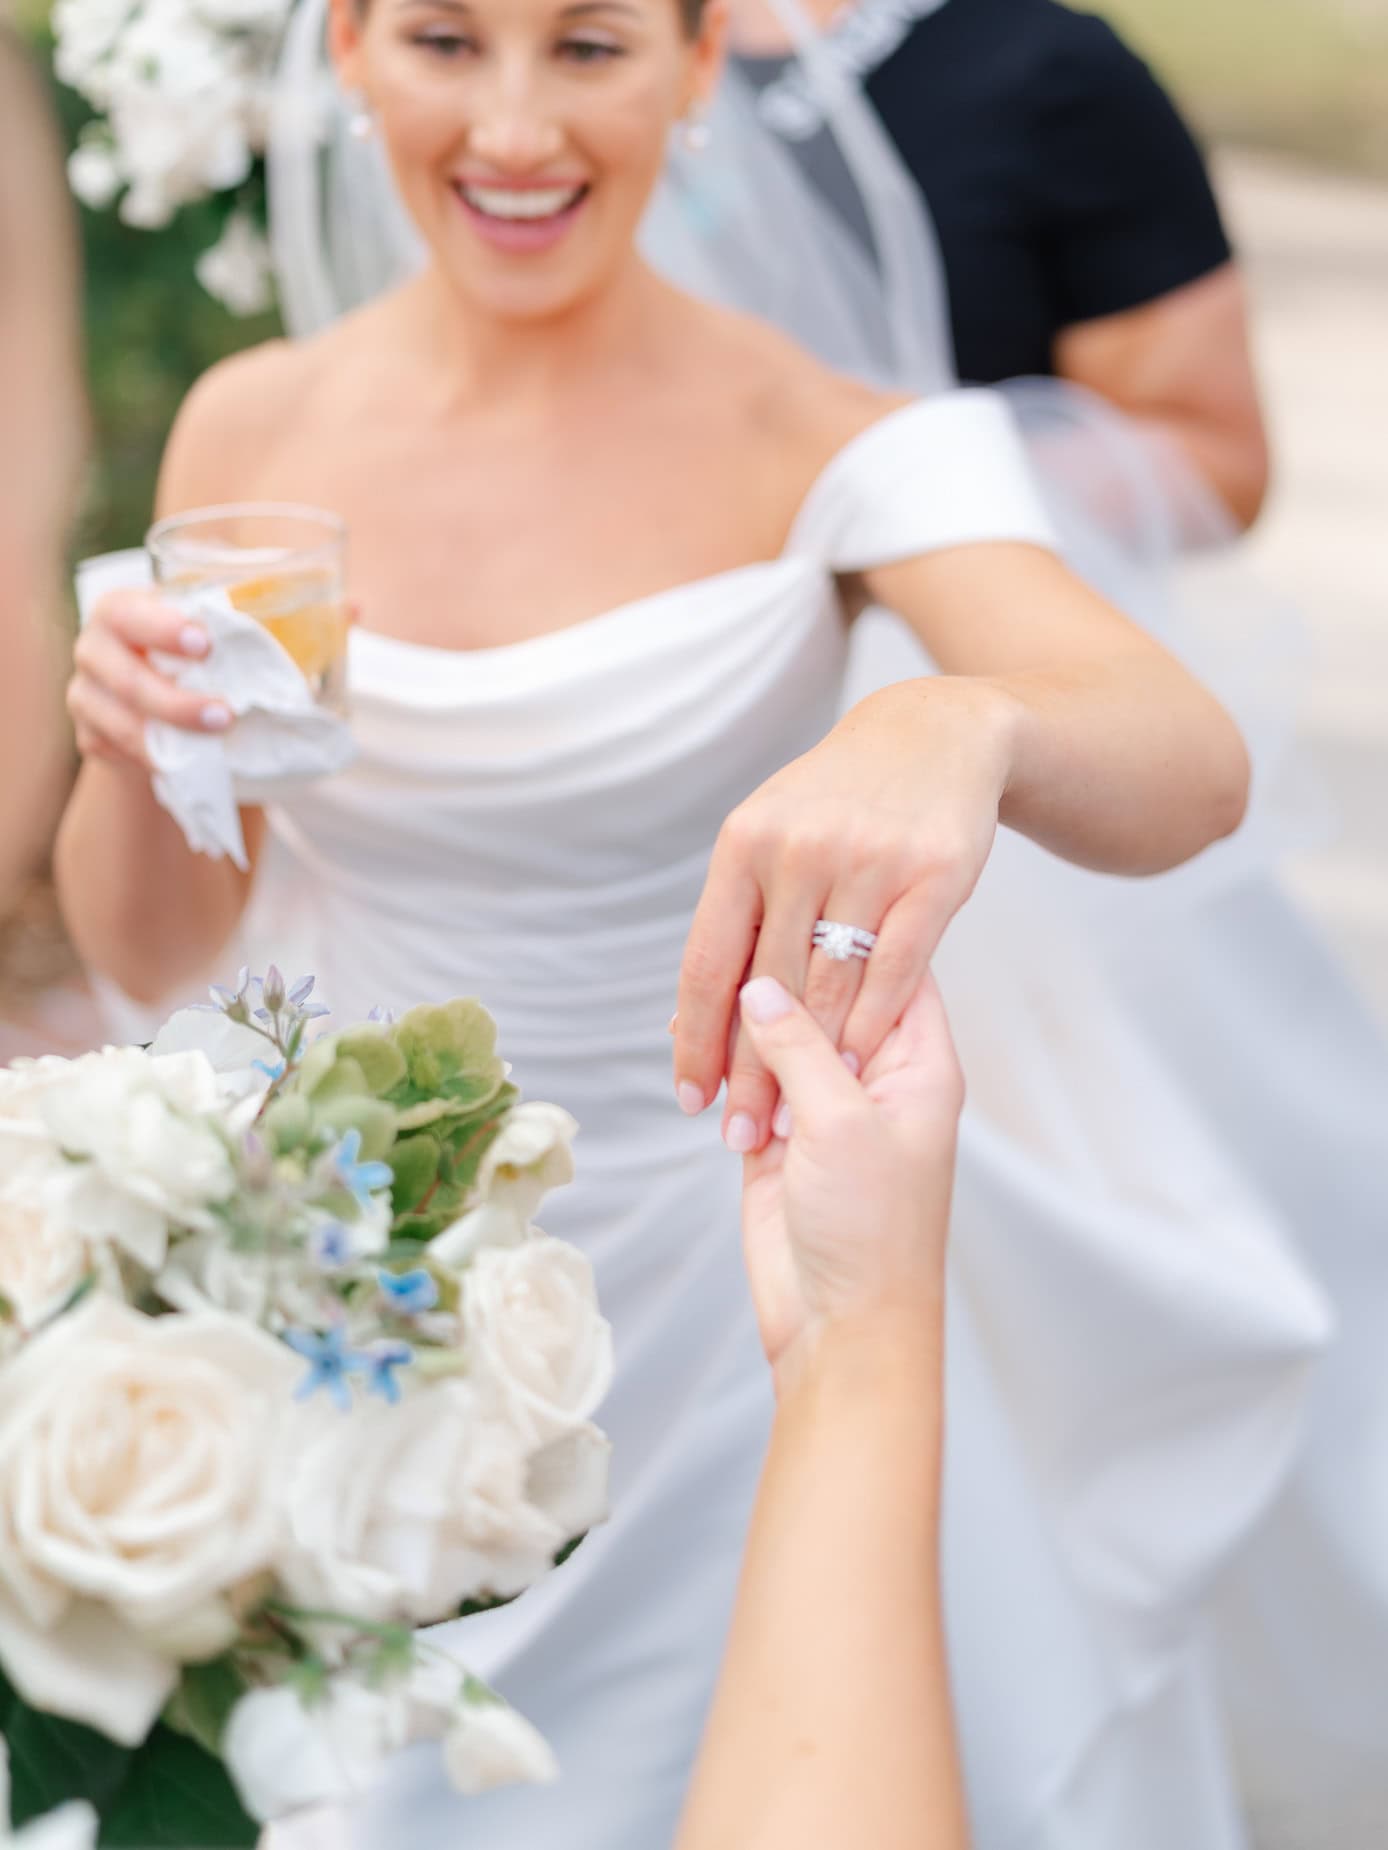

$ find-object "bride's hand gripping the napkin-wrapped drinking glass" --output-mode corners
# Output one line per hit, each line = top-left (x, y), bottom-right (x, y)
(67, 590), (231, 771)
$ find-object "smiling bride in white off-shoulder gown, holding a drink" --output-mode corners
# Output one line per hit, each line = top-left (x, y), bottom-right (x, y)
(57, 0), (1323, 1850)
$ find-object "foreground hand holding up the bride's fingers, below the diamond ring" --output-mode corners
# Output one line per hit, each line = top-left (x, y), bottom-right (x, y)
(742, 975), (964, 1376)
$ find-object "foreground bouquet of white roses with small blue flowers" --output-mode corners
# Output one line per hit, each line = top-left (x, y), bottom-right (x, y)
(0, 969), (613, 1850)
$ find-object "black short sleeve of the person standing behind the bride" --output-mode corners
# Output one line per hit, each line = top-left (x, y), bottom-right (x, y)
(1029, 15), (1231, 327)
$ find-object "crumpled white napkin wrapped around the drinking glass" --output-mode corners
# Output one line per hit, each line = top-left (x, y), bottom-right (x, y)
(78, 553), (355, 870)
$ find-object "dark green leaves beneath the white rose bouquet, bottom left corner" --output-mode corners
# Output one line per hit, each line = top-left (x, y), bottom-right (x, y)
(0, 1674), (259, 1850)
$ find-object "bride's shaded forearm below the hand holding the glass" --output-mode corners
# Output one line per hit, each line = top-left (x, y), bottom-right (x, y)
(54, 762), (263, 1003)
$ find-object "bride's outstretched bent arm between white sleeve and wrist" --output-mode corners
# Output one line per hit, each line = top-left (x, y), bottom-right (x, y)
(866, 546), (1249, 873)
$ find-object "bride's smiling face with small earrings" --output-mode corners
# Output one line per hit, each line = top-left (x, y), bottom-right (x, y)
(333, 0), (724, 320)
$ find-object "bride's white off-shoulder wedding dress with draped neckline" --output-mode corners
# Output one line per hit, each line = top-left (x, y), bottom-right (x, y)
(246, 392), (1339, 1850)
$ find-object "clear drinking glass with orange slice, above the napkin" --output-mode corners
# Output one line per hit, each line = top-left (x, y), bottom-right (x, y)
(144, 501), (348, 712)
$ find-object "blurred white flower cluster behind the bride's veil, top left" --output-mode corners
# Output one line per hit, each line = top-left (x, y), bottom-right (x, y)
(54, 0), (291, 315)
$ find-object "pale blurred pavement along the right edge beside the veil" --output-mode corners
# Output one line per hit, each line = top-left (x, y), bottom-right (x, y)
(1220, 154), (1388, 1025)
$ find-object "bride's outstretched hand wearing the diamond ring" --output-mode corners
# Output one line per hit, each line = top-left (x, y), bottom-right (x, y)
(675, 677), (1010, 1154)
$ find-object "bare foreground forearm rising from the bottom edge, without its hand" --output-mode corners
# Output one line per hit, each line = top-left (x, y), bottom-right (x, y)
(677, 1310), (968, 1850)
